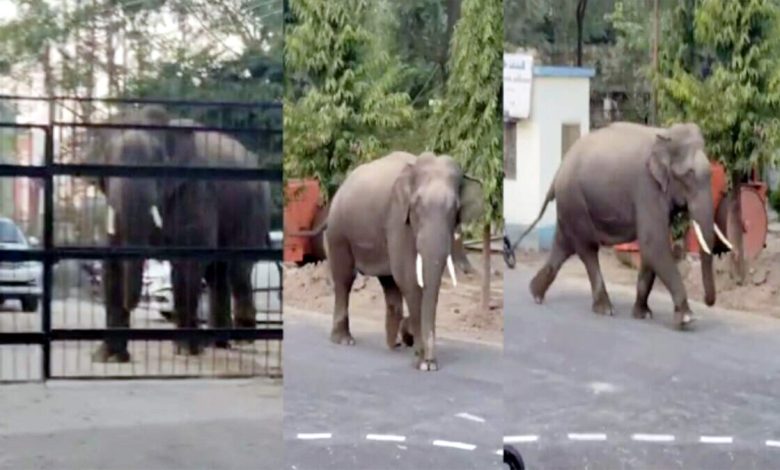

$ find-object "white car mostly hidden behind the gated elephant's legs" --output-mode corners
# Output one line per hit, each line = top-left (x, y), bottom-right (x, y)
(142, 231), (283, 322)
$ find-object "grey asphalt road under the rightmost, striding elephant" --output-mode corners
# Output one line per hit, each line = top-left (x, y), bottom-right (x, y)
(504, 261), (780, 470)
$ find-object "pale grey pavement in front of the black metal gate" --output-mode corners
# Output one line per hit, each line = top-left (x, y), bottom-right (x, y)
(0, 380), (284, 470)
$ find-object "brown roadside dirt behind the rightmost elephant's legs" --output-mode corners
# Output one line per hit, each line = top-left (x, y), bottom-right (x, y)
(517, 231), (780, 318)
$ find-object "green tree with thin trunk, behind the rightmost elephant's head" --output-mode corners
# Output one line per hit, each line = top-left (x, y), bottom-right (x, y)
(659, 0), (780, 284)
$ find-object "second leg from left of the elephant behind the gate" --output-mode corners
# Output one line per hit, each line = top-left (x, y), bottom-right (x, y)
(171, 260), (204, 355)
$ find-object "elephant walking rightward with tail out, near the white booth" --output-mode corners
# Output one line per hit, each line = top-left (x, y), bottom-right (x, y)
(514, 122), (731, 329)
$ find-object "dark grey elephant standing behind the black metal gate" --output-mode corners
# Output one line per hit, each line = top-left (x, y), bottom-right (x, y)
(87, 106), (270, 362)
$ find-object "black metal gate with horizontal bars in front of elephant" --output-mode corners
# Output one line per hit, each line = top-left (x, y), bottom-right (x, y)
(0, 96), (283, 382)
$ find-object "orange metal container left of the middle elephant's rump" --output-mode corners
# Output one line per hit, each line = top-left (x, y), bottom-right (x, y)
(284, 179), (320, 263)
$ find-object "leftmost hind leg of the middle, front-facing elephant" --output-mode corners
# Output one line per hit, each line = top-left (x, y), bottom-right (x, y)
(328, 243), (355, 346)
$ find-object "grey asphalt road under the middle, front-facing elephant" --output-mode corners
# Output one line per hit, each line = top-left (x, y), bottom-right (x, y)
(284, 309), (503, 470)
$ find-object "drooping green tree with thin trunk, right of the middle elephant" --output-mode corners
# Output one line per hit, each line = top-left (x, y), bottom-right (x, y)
(433, 0), (504, 311)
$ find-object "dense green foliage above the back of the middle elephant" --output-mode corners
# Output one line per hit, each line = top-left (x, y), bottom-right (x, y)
(284, 0), (413, 197)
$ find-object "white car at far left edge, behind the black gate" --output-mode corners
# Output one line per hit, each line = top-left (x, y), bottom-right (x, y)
(0, 217), (43, 312)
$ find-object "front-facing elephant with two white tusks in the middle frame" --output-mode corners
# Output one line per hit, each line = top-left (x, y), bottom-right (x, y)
(326, 152), (483, 371)
